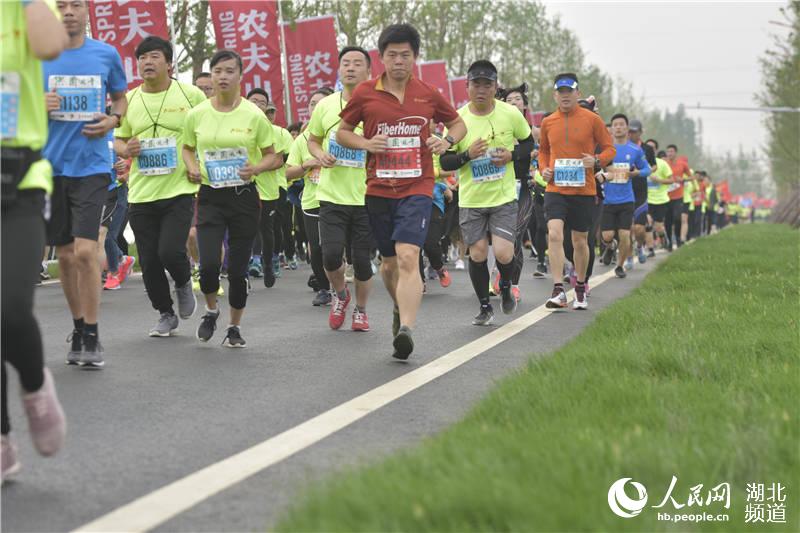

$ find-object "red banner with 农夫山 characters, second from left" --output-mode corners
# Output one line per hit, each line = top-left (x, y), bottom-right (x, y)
(209, 0), (286, 125)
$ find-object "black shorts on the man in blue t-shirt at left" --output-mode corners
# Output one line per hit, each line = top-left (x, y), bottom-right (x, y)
(47, 174), (111, 246)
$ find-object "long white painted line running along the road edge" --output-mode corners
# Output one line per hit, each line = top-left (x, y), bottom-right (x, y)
(74, 262), (628, 533)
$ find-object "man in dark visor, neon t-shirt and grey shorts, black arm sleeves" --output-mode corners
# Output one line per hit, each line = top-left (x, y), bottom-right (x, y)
(441, 60), (533, 326)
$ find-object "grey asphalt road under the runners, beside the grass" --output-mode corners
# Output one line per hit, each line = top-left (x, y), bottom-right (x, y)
(2, 252), (662, 532)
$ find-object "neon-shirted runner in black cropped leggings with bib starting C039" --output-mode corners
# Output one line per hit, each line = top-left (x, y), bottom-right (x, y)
(182, 50), (281, 348)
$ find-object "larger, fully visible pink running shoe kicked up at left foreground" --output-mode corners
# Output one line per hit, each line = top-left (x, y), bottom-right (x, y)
(22, 368), (67, 456)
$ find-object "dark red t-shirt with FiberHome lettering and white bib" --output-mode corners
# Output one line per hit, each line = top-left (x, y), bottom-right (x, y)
(339, 76), (459, 198)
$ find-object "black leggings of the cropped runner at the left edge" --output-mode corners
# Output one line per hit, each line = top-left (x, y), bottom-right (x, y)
(0, 189), (45, 435)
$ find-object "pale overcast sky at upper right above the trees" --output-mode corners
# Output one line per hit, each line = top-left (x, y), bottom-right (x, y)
(545, 1), (789, 158)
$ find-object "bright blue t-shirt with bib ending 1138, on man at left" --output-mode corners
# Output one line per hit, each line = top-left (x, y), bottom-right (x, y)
(42, 37), (128, 178)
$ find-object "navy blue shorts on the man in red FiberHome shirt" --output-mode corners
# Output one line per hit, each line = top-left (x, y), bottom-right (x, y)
(366, 194), (433, 257)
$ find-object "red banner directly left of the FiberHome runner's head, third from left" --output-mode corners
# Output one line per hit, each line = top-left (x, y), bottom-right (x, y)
(283, 15), (339, 122)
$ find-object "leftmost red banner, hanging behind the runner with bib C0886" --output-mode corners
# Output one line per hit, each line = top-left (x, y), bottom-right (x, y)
(89, 0), (169, 89)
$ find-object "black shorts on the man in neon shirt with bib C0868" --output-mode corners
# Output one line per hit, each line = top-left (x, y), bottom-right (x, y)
(319, 202), (372, 253)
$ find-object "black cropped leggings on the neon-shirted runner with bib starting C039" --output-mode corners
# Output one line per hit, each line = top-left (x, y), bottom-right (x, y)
(197, 183), (260, 309)
